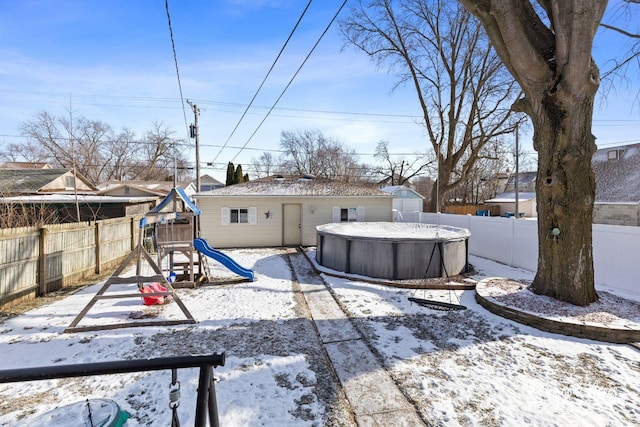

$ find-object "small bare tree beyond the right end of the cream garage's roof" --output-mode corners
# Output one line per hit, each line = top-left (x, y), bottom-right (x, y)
(374, 141), (435, 185)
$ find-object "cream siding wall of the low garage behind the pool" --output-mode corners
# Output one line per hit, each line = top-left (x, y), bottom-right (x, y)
(198, 196), (392, 248)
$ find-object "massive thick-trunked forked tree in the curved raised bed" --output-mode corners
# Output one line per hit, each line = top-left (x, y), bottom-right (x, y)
(460, 0), (607, 305)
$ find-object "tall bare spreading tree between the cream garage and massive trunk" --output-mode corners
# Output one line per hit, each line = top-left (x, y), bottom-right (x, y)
(341, 0), (519, 210)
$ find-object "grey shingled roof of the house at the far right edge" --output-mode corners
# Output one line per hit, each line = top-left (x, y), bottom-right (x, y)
(591, 144), (640, 203)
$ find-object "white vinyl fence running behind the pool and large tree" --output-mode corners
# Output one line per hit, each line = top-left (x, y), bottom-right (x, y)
(403, 212), (640, 295)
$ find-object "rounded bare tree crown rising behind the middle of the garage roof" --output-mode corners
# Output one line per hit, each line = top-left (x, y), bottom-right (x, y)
(280, 129), (360, 181)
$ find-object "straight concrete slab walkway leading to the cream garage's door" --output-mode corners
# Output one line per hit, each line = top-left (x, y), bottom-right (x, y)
(289, 251), (425, 427)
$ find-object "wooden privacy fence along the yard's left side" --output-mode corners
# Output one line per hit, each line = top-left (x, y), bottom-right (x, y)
(0, 216), (141, 307)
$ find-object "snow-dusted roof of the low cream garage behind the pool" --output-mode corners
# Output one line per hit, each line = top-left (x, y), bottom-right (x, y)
(193, 175), (393, 198)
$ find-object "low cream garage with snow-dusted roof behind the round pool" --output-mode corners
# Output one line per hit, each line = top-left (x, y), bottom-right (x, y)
(193, 175), (393, 248)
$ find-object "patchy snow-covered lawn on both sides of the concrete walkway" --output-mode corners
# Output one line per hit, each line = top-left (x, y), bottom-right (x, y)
(0, 249), (640, 426)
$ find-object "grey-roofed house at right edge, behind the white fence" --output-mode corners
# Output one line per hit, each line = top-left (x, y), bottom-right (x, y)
(592, 144), (640, 226)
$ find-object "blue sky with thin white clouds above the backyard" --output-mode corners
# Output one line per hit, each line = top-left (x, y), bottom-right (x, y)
(0, 0), (640, 181)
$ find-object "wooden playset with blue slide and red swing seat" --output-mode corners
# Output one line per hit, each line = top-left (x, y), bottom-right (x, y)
(64, 187), (255, 332)
